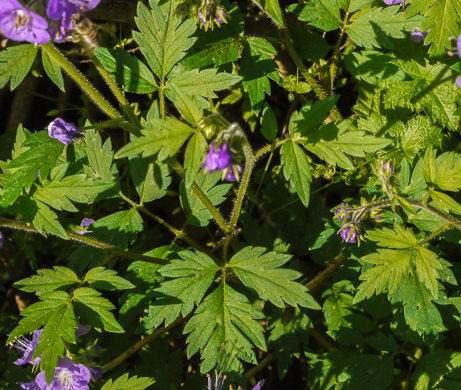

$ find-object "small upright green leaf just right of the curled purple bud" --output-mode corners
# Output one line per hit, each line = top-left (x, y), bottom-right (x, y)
(84, 129), (117, 183)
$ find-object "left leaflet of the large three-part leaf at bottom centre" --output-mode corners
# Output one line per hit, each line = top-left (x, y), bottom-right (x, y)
(144, 251), (219, 328)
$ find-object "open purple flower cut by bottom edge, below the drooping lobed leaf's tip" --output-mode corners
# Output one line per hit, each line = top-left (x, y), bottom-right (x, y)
(35, 358), (91, 390)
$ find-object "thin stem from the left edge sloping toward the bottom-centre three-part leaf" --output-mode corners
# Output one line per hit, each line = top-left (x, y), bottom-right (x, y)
(0, 218), (169, 265)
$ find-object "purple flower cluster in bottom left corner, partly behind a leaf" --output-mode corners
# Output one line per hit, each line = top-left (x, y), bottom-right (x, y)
(12, 325), (101, 390)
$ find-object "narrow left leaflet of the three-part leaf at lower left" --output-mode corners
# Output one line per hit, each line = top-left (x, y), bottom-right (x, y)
(14, 265), (81, 295)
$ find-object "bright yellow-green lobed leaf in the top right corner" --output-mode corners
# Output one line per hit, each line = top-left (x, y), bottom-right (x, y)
(407, 0), (461, 57)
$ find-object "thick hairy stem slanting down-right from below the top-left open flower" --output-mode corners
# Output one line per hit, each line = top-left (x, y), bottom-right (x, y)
(41, 43), (122, 119)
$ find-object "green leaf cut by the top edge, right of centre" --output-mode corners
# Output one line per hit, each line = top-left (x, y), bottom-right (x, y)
(288, 0), (342, 31)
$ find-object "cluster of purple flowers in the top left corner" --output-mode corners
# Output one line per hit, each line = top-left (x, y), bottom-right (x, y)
(0, 0), (101, 44)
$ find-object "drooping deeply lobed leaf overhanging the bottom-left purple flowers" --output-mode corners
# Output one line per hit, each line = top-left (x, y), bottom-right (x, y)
(8, 291), (78, 383)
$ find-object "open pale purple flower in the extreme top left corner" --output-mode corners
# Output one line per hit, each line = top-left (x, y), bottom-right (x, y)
(0, 0), (50, 44)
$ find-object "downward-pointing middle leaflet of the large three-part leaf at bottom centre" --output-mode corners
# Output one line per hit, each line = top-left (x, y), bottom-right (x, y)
(184, 284), (267, 373)
